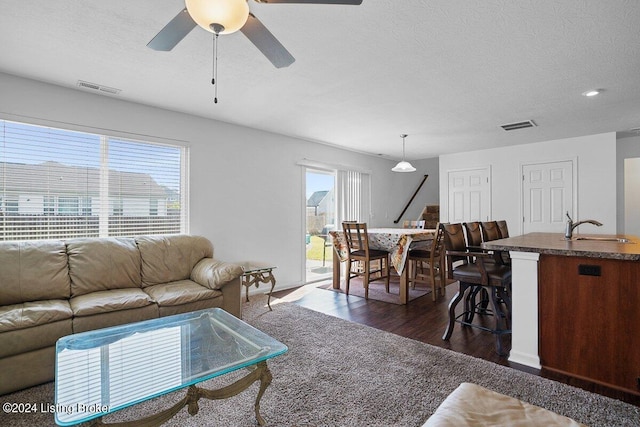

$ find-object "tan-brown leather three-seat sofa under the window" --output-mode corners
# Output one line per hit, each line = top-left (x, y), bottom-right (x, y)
(0, 235), (242, 395)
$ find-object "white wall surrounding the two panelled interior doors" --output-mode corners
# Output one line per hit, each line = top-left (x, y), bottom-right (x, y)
(440, 132), (617, 235)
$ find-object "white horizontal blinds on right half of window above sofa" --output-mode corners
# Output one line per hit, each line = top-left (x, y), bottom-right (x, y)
(108, 139), (181, 236)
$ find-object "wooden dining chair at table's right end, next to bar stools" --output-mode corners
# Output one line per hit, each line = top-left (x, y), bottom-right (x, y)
(405, 224), (447, 301)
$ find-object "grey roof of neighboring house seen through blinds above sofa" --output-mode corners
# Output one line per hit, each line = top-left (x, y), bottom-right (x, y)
(0, 162), (168, 198)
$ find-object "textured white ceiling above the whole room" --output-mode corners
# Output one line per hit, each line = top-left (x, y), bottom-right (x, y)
(0, 0), (640, 160)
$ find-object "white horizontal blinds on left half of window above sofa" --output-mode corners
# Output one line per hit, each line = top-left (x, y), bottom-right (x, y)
(0, 121), (100, 240)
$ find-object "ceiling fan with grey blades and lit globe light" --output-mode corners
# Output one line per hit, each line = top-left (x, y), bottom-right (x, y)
(147, 0), (362, 68)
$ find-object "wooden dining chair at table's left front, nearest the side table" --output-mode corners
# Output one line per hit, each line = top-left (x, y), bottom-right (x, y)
(342, 221), (389, 299)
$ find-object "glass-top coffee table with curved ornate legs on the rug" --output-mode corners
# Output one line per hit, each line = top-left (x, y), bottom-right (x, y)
(55, 308), (288, 426)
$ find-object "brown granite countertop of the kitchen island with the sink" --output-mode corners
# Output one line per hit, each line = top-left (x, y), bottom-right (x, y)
(482, 233), (640, 261)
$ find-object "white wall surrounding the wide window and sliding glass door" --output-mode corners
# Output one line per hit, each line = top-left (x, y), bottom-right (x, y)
(0, 73), (438, 288)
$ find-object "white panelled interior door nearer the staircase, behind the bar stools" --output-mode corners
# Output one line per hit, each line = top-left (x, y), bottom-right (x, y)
(448, 167), (491, 223)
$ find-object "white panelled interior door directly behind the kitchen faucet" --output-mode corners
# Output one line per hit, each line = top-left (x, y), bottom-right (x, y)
(522, 160), (575, 233)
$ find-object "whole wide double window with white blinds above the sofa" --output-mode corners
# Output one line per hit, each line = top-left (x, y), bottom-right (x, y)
(0, 120), (188, 240)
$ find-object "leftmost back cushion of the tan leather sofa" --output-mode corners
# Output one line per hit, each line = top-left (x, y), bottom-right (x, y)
(0, 240), (70, 305)
